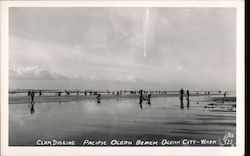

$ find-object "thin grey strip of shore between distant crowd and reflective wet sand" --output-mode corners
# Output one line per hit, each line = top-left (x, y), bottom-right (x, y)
(9, 94), (228, 104)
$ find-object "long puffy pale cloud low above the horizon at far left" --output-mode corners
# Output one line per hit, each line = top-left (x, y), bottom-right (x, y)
(9, 66), (67, 80)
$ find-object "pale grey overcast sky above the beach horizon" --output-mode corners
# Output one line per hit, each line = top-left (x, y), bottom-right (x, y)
(9, 8), (236, 90)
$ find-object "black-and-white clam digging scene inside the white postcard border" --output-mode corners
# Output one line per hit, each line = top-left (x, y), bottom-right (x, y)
(1, 0), (244, 154)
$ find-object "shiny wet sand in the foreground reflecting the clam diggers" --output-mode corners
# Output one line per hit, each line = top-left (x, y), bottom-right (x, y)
(9, 95), (236, 146)
